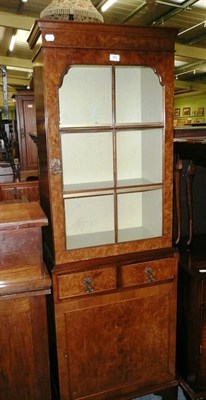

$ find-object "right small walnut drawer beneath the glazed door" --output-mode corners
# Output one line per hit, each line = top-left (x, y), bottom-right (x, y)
(121, 258), (174, 287)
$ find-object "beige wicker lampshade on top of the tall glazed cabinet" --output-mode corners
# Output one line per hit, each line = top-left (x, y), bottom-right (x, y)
(40, 0), (103, 22)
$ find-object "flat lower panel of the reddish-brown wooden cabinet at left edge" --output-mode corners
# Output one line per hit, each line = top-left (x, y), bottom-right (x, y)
(0, 296), (51, 400)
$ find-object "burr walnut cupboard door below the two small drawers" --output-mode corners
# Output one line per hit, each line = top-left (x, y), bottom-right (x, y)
(56, 283), (175, 400)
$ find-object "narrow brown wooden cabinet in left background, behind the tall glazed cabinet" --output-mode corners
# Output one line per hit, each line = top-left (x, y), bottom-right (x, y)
(16, 91), (38, 180)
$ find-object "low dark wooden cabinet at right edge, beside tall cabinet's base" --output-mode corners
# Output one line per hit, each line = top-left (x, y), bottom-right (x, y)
(177, 235), (206, 400)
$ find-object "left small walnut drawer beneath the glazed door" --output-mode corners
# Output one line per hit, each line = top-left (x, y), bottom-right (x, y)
(57, 265), (116, 300)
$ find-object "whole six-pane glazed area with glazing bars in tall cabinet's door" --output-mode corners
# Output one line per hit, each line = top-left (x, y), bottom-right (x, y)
(59, 65), (164, 250)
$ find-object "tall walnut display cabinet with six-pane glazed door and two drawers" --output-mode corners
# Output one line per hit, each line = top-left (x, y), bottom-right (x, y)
(28, 20), (177, 400)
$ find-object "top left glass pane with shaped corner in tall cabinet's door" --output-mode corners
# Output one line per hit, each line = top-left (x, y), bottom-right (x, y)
(59, 66), (112, 127)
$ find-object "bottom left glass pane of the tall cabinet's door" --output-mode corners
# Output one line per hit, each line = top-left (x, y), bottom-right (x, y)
(64, 195), (115, 249)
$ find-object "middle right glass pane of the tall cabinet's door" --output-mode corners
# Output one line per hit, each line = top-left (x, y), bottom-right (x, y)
(117, 129), (162, 186)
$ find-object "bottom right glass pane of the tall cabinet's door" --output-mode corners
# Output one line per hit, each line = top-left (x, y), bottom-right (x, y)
(117, 189), (162, 242)
